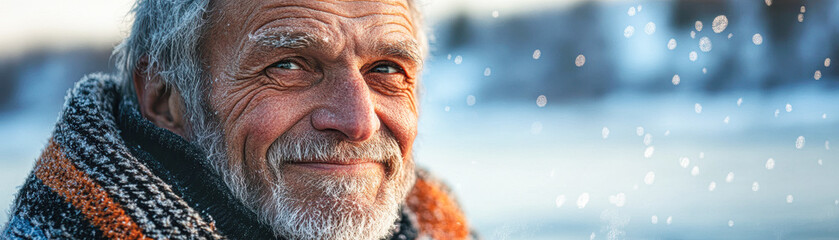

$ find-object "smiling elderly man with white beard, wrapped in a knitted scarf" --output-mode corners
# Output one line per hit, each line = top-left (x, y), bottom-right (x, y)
(2, 0), (472, 239)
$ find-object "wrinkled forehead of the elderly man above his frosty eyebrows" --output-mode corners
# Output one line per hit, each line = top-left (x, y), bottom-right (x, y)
(212, 0), (417, 47)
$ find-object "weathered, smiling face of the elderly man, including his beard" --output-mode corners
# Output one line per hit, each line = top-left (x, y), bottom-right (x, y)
(202, 0), (422, 237)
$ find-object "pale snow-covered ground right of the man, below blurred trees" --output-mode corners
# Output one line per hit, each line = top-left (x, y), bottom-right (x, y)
(416, 84), (839, 239)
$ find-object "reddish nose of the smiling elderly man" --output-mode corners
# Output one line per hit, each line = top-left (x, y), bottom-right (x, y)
(312, 71), (381, 142)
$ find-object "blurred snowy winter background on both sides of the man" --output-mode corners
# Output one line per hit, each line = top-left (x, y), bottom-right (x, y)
(0, 0), (839, 239)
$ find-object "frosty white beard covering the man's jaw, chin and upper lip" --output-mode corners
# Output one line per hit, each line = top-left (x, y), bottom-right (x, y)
(194, 120), (416, 240)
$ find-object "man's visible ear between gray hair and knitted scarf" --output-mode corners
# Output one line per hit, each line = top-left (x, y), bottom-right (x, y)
(133, 57), (186, 138)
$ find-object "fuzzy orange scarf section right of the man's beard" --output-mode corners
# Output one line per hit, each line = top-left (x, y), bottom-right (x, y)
(407, 177), (469, 239)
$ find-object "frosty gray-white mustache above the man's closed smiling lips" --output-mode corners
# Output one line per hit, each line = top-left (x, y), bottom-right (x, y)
(267, 128), (402, 167)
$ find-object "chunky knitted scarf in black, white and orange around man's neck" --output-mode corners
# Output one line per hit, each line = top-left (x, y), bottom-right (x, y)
(0, 74), (472, 239)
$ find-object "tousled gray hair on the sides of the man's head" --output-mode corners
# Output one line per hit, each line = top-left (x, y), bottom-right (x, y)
(112, 0), (428, 120)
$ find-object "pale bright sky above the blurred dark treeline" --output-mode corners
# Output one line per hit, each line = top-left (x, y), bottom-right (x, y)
(0, 0), (582, 56)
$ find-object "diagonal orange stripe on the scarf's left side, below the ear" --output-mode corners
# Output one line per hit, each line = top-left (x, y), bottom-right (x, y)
(35, 140), (150, 239)
